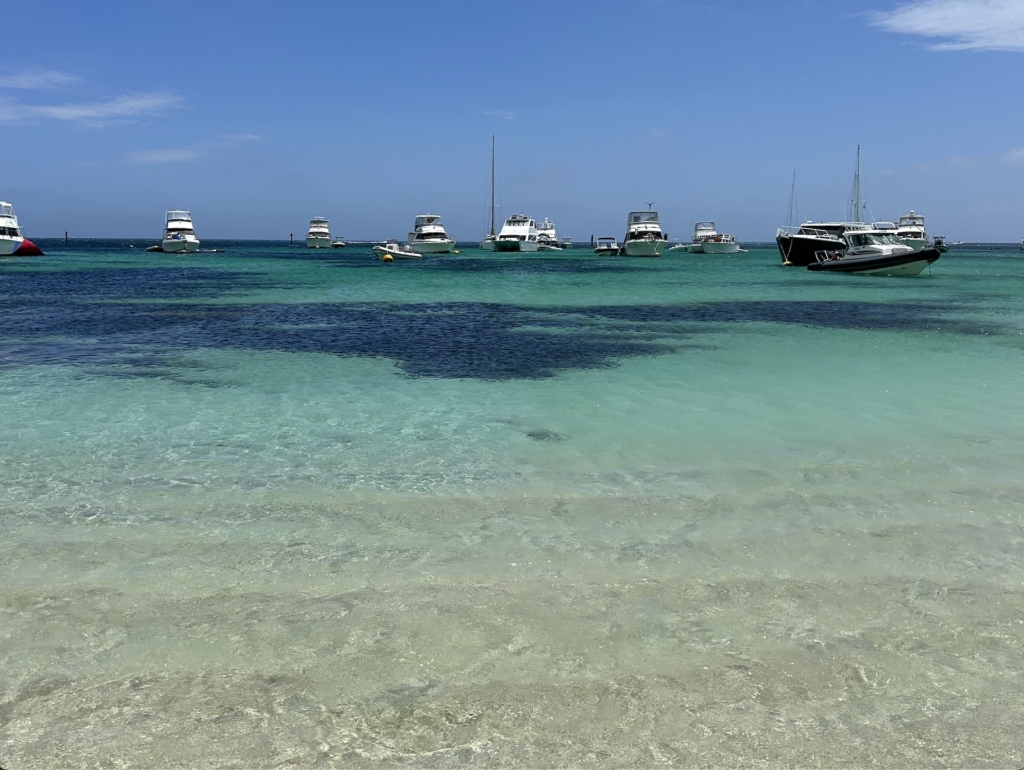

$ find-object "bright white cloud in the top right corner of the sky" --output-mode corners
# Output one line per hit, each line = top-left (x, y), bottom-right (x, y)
(868, 0), (1024, 51)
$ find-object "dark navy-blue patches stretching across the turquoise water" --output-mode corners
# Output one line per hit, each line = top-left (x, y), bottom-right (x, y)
(0, 260), (1000, 380)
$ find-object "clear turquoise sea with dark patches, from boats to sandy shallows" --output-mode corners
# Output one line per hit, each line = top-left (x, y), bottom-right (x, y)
(0, 241), (1024, 767)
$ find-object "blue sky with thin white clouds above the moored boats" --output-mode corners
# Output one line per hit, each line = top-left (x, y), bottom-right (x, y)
(0, 0), (1024, 242)
